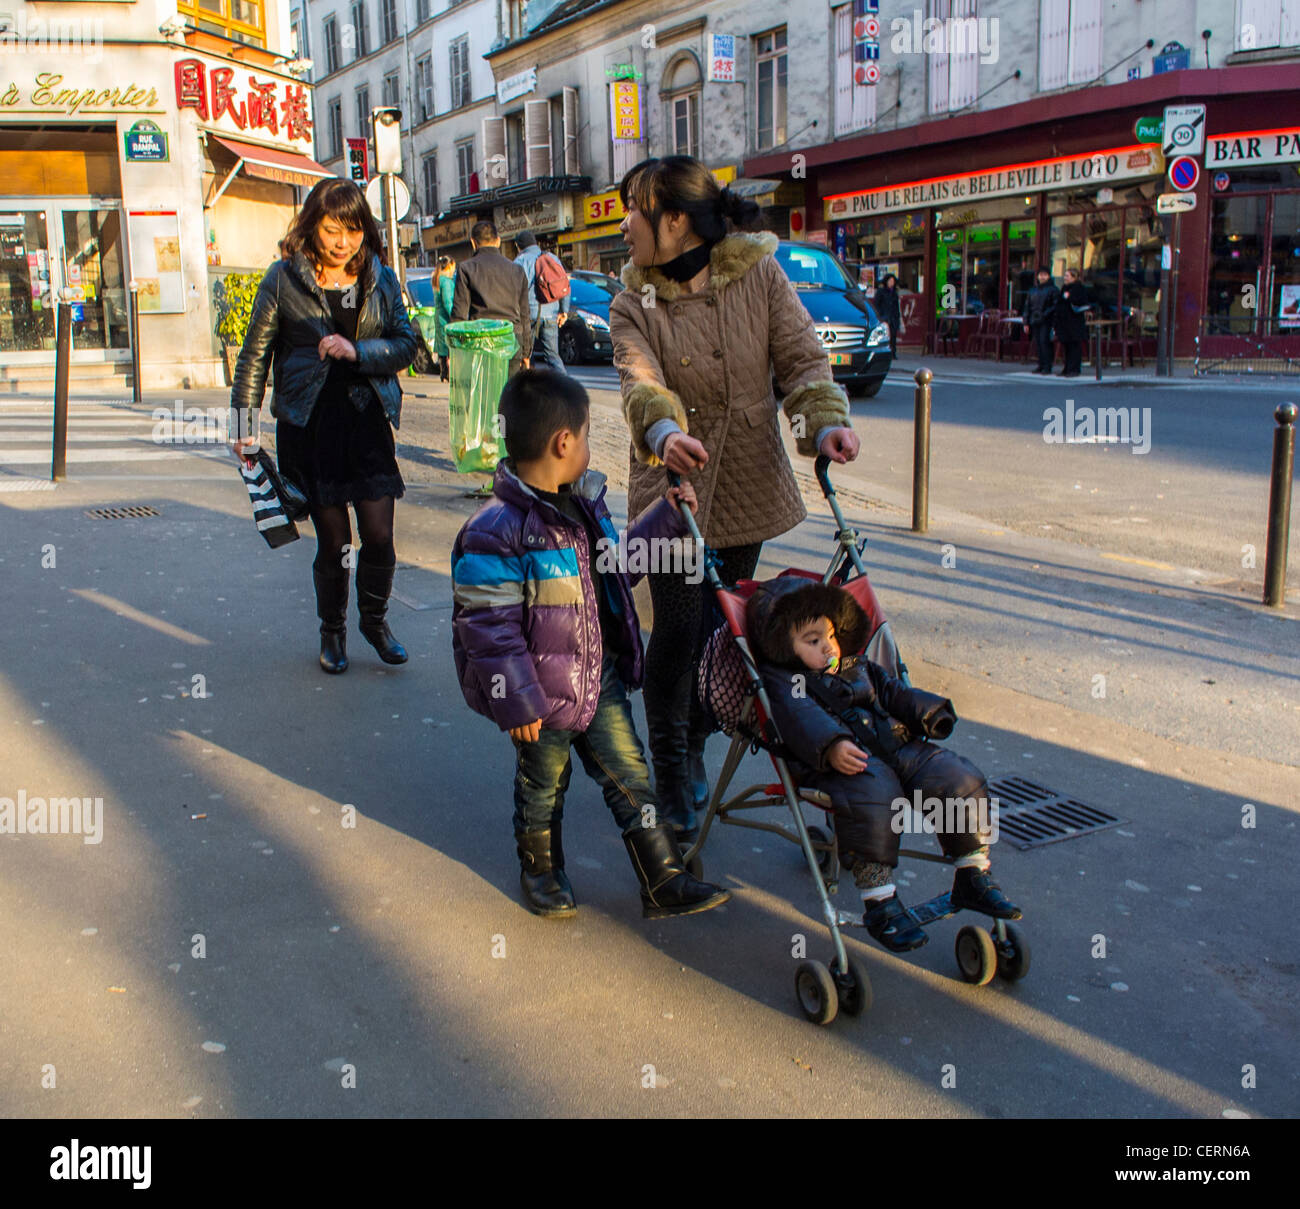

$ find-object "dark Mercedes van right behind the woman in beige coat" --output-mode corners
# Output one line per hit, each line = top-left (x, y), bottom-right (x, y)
(776, 239), (893, 399)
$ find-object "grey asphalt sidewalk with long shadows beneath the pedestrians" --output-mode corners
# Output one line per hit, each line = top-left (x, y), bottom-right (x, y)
(0, 380), (1300, 1118)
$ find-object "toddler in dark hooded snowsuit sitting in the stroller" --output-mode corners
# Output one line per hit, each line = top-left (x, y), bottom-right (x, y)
(748, 576), (1021, 953)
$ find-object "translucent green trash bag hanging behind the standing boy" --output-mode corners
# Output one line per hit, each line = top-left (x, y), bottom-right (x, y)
(446, 319), (519, 473)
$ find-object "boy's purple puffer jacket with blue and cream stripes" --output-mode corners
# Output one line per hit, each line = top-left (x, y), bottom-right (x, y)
(451, 459), (685, 731)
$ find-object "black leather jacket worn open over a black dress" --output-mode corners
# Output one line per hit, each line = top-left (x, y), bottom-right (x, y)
(230, 252), (416, 430)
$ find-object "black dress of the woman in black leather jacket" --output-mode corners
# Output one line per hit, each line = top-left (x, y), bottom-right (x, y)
(276, 286), (406, 508)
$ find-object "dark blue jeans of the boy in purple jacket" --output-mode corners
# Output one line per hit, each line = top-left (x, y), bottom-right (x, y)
(515, 655), (650, 833)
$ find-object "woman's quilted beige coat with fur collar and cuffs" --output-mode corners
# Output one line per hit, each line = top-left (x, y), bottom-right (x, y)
(610, 231), (850, 549)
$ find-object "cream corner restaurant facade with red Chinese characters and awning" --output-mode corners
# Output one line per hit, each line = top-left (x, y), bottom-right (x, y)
(0, 0), (328, 389)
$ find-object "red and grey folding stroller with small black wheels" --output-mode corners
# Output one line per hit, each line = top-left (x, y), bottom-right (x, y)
(668, 455), (1030, 1024)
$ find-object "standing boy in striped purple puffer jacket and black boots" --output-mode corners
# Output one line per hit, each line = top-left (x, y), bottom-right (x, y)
(451, 369), (731, 919)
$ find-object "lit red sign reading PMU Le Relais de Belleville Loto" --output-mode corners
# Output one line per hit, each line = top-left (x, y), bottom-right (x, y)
(823, 144), (1165, 222)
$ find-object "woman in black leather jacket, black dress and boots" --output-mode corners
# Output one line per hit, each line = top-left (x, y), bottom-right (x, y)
(230, 178), (416, 672)
